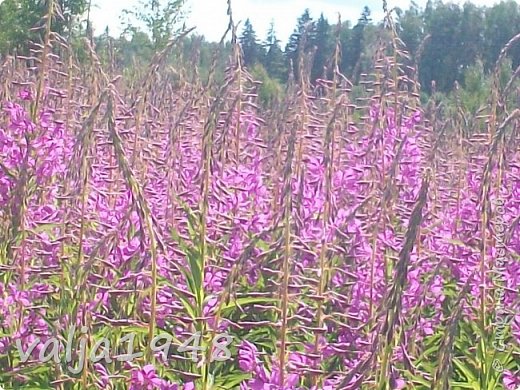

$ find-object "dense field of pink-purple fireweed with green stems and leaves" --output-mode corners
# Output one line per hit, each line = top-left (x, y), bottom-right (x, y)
(0, 6), (520, 390)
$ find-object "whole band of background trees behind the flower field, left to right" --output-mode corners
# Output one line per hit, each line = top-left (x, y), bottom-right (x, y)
(0, 0), (520, 94)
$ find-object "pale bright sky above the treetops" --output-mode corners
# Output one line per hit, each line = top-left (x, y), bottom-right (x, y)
(91, 0), (502, 43)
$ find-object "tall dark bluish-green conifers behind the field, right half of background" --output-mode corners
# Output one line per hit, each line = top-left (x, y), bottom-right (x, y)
(240, 0), (520, 92)
